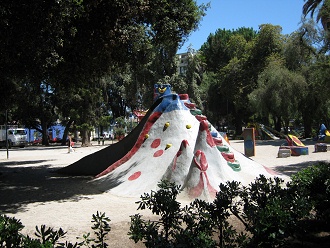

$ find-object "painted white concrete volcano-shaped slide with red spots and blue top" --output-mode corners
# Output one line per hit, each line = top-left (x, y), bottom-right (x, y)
(59, 85), (277, 200)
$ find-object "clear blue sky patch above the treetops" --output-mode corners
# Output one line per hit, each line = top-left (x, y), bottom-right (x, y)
(179, 0), (304, 53)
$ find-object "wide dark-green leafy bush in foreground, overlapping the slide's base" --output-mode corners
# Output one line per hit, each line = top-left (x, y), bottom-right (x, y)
(128, 175), (310, 247)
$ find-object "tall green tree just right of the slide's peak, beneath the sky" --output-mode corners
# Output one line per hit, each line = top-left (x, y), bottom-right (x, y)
(201, 28), (257, 134)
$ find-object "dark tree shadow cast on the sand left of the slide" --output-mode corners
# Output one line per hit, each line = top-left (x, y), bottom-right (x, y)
(0, 160), (102, 214)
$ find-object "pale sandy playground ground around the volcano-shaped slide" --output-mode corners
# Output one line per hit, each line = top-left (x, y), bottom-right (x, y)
(0, 140), (330, 247)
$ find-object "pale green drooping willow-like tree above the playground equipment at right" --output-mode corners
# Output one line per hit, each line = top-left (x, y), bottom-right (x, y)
(249, 57), (307, 131)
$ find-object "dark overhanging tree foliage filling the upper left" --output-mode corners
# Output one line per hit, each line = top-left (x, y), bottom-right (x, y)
(0, 0), (208, 143)
